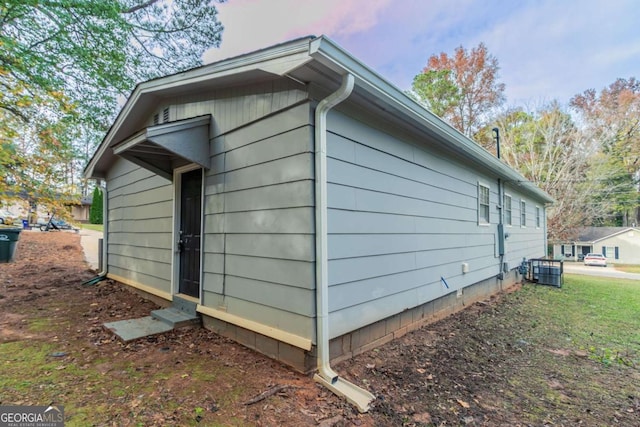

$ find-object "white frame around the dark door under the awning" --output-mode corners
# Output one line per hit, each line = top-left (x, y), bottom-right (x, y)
(171, 163), (206, 304)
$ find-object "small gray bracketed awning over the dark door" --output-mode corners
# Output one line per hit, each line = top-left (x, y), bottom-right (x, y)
(113, 116), (211, 181)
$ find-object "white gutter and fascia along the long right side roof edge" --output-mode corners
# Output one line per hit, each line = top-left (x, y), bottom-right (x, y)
(309, 36), (554, 203)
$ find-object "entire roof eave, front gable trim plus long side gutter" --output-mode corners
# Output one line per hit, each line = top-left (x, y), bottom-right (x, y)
(85, 36), (554, 203)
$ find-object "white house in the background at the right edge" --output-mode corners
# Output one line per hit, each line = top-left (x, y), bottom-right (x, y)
(553, 227), (640, 264)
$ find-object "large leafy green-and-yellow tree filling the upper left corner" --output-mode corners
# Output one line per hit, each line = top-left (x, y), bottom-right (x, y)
(0, 0), (223, 210)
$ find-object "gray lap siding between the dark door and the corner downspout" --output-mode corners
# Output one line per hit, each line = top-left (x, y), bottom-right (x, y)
(203, 99), (315, 339)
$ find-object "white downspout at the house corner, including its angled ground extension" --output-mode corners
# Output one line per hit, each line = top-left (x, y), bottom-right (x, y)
(314, 74), (375, 412)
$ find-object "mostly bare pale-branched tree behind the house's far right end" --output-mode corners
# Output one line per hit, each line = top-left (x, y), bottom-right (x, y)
(496, 102), (615, 240)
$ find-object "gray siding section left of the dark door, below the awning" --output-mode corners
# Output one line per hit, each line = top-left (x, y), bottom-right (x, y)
(107, 159), (173, 293)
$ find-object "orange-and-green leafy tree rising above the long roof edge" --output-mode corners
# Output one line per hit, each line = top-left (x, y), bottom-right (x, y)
(412, 43), (505, 137)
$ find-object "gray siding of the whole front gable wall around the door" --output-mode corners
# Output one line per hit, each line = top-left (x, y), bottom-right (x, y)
(110, 79), (315, 338)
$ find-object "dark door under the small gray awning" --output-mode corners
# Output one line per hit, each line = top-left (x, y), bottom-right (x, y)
(179, 169), (202, 298)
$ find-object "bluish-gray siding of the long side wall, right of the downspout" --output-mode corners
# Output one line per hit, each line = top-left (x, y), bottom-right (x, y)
(327, 111), (542, 337)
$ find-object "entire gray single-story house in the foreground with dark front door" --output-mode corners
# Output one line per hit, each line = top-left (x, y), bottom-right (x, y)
(85, 37), (552, 407)
